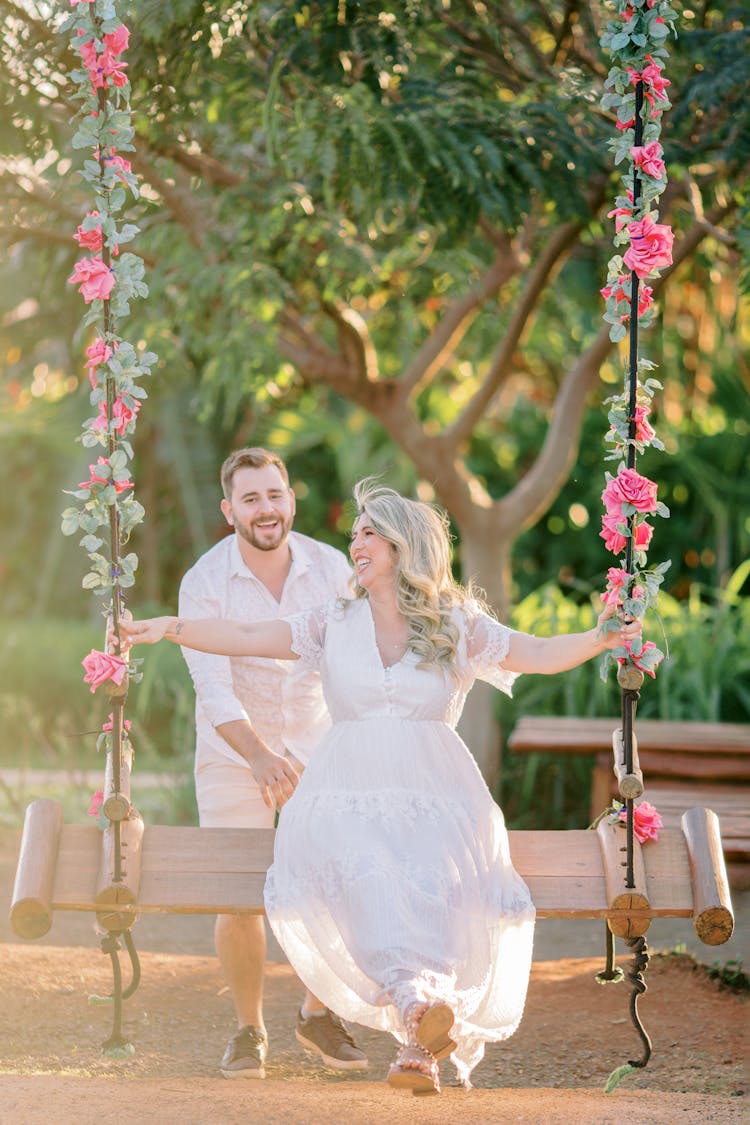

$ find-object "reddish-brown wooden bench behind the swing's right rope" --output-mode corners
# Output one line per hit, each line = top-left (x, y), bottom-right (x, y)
(508, 716), (750, 885)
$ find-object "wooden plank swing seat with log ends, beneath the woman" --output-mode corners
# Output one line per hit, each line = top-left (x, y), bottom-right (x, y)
(10, 799), (734, 945)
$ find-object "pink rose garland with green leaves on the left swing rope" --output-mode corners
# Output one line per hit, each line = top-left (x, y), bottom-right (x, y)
(60, 0), (156, 828)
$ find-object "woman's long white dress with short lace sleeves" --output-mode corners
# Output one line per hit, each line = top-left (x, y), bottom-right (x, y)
(265, 600), (534, 1081)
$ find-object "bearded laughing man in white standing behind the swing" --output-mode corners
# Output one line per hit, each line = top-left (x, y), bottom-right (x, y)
(179, 448), (368, 1078)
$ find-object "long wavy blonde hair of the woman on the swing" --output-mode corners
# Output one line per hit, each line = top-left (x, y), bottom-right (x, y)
(354, 477), (476, 667)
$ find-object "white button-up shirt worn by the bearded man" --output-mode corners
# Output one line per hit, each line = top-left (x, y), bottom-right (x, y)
(179, 531), (352, 771)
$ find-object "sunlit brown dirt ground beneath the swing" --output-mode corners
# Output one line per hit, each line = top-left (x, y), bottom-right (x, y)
(0, 833), (750, 1125)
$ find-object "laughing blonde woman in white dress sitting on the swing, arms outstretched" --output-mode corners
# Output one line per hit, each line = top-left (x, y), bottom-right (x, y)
(124, 482), (641, 1094)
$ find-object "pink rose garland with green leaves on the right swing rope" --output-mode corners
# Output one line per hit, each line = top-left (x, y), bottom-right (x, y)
(599, 0), (674, 676)
